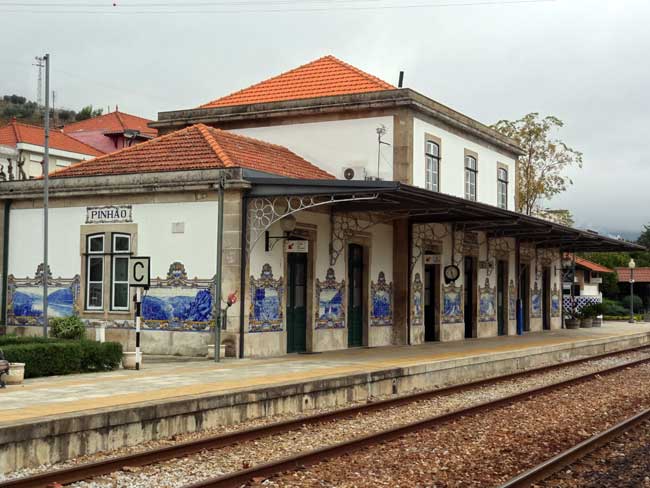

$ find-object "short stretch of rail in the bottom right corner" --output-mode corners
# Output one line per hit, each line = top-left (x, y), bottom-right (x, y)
(499, 408), (650, 488)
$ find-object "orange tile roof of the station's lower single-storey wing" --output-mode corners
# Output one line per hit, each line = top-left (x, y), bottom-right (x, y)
(52, 124), (334, 179)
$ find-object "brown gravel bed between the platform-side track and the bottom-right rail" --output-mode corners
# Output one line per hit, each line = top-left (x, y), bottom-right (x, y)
(264, 364), (650, 487)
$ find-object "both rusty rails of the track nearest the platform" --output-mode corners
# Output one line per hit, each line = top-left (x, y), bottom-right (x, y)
(5, 346), (650, 488)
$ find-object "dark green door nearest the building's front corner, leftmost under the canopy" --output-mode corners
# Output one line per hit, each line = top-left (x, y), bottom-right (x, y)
(287, 253), (307, 352)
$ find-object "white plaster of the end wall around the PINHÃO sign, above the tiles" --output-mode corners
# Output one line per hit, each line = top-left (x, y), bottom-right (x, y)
(8, 202), (217, 278)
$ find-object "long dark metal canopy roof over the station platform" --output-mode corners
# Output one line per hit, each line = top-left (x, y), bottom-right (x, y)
(245, 174), (645, 252)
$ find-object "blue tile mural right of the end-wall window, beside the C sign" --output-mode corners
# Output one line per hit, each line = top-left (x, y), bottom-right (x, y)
(142, 261), (214, 331)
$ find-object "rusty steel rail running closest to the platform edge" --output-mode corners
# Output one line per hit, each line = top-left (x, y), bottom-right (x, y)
(0, 345), (650, 488)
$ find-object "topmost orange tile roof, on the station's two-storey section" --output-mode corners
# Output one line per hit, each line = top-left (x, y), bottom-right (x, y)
(199, 56), (395, 108)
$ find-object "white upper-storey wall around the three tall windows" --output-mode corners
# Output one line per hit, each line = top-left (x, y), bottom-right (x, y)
(413, 118), (515, 210)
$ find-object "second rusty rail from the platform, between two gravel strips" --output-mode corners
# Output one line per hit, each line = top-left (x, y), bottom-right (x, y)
(183, 358), (650, 488)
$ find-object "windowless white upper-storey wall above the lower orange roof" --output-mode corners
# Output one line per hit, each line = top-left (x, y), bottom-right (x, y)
(232, 117), (393, 180)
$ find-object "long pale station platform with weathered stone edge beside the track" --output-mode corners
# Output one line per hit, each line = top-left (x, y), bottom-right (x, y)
(0, 322), (650, 473)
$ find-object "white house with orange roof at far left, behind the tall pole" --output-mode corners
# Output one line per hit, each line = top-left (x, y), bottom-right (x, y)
(0, 119), (104, 179)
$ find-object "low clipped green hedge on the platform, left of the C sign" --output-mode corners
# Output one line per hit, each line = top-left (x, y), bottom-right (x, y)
(2, 340), (122, 378)
